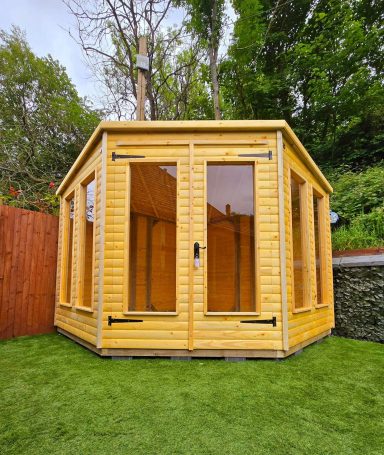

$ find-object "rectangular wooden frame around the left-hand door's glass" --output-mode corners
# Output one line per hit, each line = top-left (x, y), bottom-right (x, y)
(123, 161), (181, 316)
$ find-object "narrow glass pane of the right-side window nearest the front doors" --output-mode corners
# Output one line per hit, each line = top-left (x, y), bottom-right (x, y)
(291, 176), (304, 308)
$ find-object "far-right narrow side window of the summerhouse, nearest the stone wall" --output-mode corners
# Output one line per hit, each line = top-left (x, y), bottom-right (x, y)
(313, 190), (326, 305)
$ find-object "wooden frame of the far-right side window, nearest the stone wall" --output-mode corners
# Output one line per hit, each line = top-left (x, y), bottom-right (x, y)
(312, 186), (329, 309)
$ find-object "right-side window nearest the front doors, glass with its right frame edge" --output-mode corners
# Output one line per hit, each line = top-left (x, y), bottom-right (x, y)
(291, 171), (310, 310)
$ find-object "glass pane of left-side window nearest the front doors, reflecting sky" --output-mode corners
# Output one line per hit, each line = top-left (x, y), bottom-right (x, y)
(83, 180), (95, 307)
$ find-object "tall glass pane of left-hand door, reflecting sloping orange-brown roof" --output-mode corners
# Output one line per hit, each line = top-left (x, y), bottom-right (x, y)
(129, 163), (177, 311)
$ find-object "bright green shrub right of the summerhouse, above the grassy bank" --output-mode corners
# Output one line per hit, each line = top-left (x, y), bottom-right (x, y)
(330, 164), (384, 223)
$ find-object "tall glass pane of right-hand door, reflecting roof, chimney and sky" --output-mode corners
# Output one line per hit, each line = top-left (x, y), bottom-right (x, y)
(207, 163), (256, 312)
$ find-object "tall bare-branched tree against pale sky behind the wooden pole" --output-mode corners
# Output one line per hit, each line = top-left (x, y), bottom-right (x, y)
(65, 0), (201, 120)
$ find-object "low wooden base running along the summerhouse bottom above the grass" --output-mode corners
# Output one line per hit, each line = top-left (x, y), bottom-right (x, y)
(57, 327), (331, 359)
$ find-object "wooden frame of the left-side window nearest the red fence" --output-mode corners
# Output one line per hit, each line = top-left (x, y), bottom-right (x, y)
(59, 189), (77, 307)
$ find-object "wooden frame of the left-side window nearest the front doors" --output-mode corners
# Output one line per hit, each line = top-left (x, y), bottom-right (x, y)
(75, 168), (98, 313)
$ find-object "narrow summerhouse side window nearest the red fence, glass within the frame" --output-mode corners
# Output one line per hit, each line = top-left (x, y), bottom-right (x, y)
(61, 193), (75, 304)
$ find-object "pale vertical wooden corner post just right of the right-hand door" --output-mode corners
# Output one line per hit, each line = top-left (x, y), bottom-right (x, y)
(276, 130), (289, 351)
